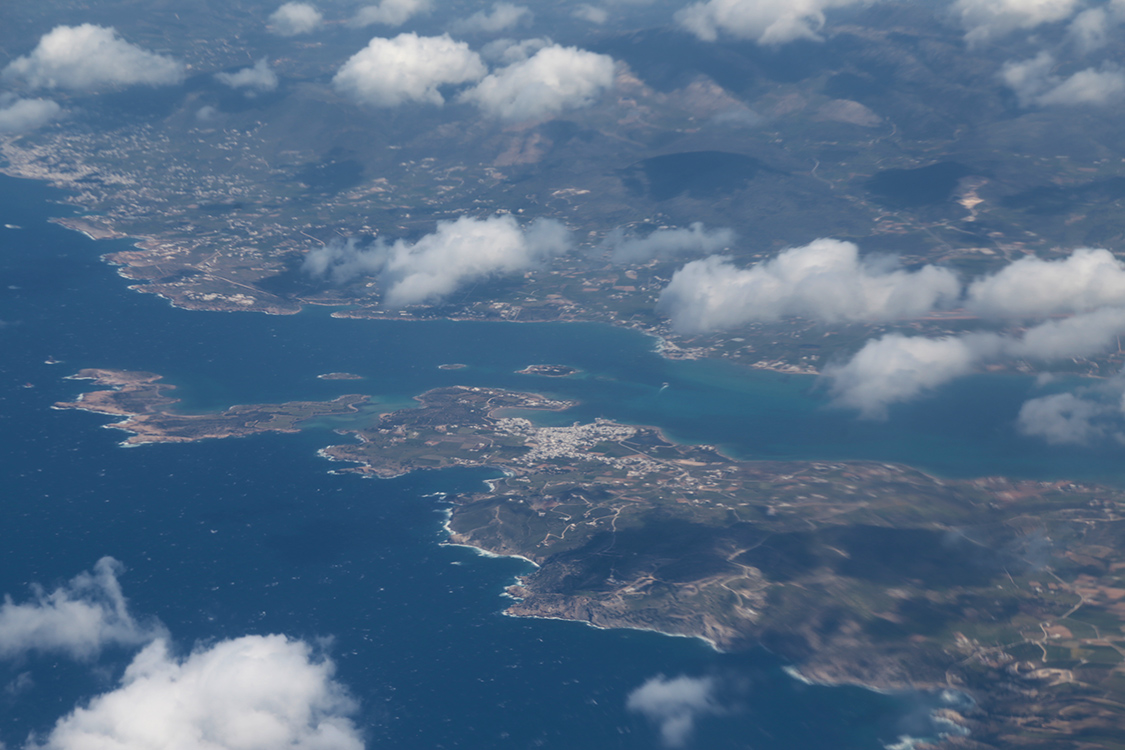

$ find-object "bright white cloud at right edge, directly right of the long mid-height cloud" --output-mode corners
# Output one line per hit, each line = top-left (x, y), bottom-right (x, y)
(965, 247), (1125, 318)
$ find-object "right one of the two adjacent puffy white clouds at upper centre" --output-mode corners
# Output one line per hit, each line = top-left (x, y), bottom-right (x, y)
(460, 45), (614, 120)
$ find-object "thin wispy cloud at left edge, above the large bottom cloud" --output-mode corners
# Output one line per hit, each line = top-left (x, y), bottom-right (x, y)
(0, 558), (163, 659)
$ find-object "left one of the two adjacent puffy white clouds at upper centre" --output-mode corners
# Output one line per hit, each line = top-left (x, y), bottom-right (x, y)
(332, 34), (487, 107)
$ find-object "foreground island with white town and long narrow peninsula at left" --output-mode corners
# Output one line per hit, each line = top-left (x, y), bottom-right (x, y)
(55, 370), (1125, 748)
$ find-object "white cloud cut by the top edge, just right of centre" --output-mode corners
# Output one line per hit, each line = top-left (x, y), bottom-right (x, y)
(676, 0), (869, 44)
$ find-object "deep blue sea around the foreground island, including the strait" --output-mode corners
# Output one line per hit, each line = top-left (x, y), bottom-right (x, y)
(0, 178), (1123, 750)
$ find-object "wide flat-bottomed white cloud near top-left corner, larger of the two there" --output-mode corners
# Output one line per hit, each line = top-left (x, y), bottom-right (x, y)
(3, 24), (185, 91)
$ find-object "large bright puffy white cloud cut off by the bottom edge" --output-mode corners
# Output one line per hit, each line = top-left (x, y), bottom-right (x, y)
(28, 635), (363, 750)
